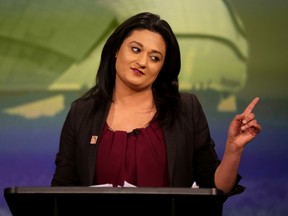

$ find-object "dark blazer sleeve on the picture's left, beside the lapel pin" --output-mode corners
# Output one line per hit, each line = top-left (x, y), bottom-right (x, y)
(51, 98), (102, 186)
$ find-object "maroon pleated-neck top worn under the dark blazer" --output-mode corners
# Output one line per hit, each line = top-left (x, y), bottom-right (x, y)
(94, 120), (168, 187)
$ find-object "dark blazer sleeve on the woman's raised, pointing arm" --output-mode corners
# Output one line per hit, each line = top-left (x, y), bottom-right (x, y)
(185, 94), (245, 196)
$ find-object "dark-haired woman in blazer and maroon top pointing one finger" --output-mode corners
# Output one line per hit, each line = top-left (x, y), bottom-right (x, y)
(51, 12), (261, 194)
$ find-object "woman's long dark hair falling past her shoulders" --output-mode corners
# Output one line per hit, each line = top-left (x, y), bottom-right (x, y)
(83, 12), (181, 126)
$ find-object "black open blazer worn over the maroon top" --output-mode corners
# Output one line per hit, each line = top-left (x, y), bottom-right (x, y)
(51, 93), (240, 191)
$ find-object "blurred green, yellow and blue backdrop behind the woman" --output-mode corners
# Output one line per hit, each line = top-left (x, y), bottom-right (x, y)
(0, 0), (288, 216)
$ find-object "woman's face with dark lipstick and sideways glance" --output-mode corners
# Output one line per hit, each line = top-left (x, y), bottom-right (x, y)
(115, 30), (166, 91)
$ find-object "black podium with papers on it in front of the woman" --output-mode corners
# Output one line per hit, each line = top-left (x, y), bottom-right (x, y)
(4, 186), (225, 216)
